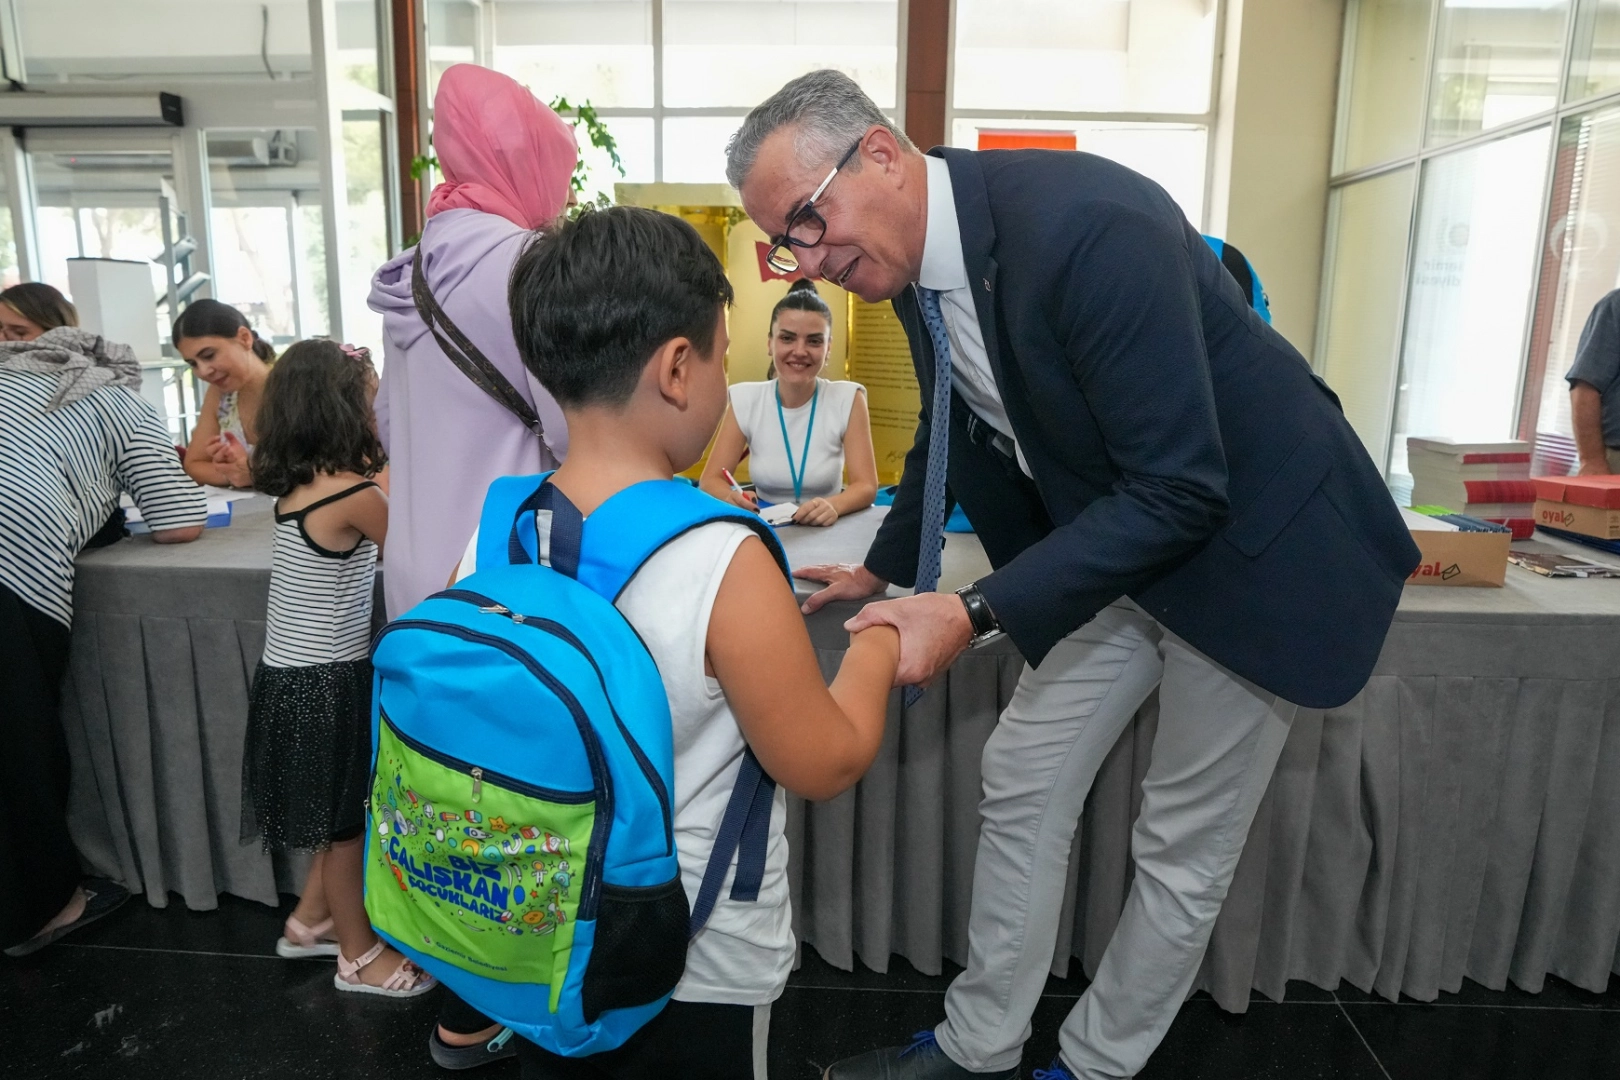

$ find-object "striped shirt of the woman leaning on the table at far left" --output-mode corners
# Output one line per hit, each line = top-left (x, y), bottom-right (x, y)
(0, 369), (207, 627)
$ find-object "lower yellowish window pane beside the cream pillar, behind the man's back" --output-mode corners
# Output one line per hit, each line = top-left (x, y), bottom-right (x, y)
(1320, 167), (1416, 463)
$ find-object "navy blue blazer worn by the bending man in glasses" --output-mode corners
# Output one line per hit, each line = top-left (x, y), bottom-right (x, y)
(867, 149), (1419, 708)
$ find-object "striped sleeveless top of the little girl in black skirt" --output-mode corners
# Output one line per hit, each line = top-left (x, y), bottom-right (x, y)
(264, 481), (377, 667)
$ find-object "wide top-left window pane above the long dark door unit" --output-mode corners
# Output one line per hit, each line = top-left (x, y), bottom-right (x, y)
(15, 0), (312, 87)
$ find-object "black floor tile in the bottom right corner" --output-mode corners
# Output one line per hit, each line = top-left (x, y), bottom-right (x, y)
(1345, 1004), (1620, 1080)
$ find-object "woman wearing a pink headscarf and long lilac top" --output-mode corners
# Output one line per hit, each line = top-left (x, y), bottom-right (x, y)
(368, 63), (578, 617)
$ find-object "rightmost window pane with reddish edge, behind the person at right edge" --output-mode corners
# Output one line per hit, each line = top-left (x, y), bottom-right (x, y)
(1524, 108), (1620, 473)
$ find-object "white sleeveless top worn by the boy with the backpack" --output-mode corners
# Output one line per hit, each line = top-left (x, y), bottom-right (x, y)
(455, 515), (795, 1006)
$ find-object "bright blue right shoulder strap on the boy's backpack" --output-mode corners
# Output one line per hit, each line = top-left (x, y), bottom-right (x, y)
(578, 479), (792, 601)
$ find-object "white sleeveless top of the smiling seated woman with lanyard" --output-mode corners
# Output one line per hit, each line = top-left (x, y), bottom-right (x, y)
(731, 379), (863, 502)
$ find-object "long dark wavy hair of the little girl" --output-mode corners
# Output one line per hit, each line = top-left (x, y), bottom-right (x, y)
(253, 340), (389, 495)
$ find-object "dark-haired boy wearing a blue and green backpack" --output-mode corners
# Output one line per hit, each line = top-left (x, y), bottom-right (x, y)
(368, 207), (899, 1080)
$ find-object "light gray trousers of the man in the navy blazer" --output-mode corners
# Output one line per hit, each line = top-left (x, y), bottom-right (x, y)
(936, 599), (1294, 1080)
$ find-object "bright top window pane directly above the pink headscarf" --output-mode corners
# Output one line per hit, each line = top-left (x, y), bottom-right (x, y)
(489, 0), (654, 108)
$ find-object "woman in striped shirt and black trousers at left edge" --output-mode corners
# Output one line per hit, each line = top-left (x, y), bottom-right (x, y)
(0, 325), (207, 955)
